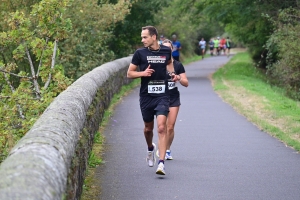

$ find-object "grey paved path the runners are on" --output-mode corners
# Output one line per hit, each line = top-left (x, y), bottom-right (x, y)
(96, 56), (300, 200)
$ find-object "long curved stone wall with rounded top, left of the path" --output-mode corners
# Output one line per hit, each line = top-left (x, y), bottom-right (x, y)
(0, 57), (131, 200)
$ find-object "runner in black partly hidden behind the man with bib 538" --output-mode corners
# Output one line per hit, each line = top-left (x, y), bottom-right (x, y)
(163, 40), (189, 160)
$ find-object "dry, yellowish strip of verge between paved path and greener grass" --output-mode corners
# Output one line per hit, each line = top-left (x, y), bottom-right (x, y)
(209, 52), (300, 151)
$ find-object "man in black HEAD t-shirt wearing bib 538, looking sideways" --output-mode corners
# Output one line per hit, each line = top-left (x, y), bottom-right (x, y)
(127, 26), (178, 175)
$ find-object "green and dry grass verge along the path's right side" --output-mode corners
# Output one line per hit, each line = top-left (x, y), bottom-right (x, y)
(212, 52), (300, 152)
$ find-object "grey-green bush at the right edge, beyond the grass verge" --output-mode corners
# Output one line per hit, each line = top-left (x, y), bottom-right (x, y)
(266, 8), (300, 100)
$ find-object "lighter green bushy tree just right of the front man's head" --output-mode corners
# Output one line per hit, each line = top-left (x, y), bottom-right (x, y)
(156, 0), (224, 60)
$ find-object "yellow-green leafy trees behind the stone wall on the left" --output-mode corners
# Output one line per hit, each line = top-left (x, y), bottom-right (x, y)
(0, 0), (131, 162)
